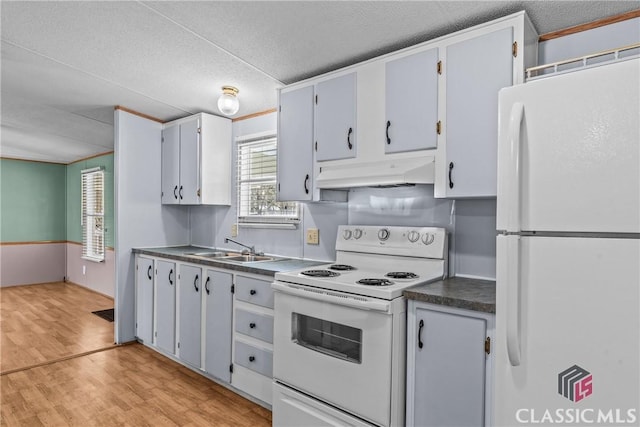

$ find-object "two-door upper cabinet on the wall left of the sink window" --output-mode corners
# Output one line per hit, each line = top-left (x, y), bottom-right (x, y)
(162, 113), (232, 205)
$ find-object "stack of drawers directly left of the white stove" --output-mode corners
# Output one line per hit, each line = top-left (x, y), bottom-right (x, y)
(231, 274), (273, 404)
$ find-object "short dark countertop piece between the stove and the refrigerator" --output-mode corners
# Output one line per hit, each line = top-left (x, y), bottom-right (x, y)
(404, 277), (496, 314)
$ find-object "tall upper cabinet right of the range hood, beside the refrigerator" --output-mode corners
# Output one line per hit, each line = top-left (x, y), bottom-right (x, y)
(434, 13), (538, 198)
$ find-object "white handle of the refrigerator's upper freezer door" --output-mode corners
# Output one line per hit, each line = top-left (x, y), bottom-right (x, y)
(501, 102), (524, 232)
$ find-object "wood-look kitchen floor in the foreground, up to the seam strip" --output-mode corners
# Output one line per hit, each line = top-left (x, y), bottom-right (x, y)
(0, 343), (271, 427)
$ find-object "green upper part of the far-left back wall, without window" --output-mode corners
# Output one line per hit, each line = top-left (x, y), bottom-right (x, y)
(0, 159), (67, 242)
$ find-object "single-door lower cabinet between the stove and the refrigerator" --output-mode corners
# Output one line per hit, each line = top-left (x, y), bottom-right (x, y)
(406, 300), (495, 427)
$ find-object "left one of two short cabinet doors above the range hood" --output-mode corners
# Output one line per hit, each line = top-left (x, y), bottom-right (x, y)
(316, 73), (357, 161)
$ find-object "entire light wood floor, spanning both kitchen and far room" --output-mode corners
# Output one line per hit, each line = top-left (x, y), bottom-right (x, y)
(0, 284), (271, 427)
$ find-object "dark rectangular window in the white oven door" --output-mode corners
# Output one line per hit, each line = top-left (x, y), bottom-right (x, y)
(291, 312), (362, 363)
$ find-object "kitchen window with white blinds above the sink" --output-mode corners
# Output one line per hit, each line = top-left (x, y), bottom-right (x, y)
(238, 134), (299, 224)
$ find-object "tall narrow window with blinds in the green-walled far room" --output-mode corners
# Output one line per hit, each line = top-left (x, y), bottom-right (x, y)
(81, 168), (104, 262)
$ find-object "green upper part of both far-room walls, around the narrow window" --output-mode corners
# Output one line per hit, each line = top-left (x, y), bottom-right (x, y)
(0, 154), (115, 247)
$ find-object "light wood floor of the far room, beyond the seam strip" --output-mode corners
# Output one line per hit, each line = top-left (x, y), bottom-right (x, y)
(0, 282), (114, 372)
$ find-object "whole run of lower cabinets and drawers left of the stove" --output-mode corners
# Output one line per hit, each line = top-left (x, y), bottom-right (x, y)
(135, 254), (273, 405)
